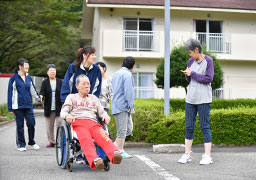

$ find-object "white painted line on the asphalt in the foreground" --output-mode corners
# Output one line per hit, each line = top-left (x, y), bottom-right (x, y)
(135, 155), (180, 180)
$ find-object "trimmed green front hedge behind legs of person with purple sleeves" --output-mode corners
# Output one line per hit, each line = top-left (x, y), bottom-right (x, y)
(145, 107), (256, 144)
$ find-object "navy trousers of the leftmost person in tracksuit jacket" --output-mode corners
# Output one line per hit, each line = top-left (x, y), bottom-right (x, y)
(14, 109), (36, 148)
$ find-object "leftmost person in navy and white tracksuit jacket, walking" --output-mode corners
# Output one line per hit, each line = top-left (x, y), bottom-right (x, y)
(8, 58), (40, 151)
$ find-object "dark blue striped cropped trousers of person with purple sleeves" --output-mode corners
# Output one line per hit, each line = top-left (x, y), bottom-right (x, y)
(185, 103), (212, 143)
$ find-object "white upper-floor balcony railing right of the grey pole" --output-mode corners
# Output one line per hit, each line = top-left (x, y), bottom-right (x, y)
(196, 33), (231, 54)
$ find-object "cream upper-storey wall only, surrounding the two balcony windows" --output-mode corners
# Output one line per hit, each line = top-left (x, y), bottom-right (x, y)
(96, 8), (256, 61)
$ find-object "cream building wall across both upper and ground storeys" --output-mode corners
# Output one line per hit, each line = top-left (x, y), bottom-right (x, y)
(89, 8), (256, 98)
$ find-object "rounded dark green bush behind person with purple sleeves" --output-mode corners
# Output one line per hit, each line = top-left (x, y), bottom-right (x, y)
(155, 46), (223, 92)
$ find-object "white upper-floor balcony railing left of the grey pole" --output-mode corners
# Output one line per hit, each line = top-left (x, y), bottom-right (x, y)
(123, 30), (160, 52)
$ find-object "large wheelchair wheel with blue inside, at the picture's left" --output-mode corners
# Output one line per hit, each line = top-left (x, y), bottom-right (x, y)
(56, 122), (70, 169)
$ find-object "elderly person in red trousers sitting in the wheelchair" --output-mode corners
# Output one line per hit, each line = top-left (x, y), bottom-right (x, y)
(61, 75), (122, 169)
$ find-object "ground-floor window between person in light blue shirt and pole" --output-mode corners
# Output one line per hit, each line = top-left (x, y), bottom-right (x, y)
(132, 72), (154, 98)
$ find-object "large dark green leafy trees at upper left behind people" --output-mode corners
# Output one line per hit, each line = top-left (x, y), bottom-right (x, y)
(0, 0), (83, 77)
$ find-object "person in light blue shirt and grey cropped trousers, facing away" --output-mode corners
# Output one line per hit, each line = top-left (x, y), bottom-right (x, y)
(112, 56), (135, 158)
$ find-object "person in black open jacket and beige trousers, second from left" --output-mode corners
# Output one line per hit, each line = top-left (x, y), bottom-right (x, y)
(40, 64), (62, 147)
